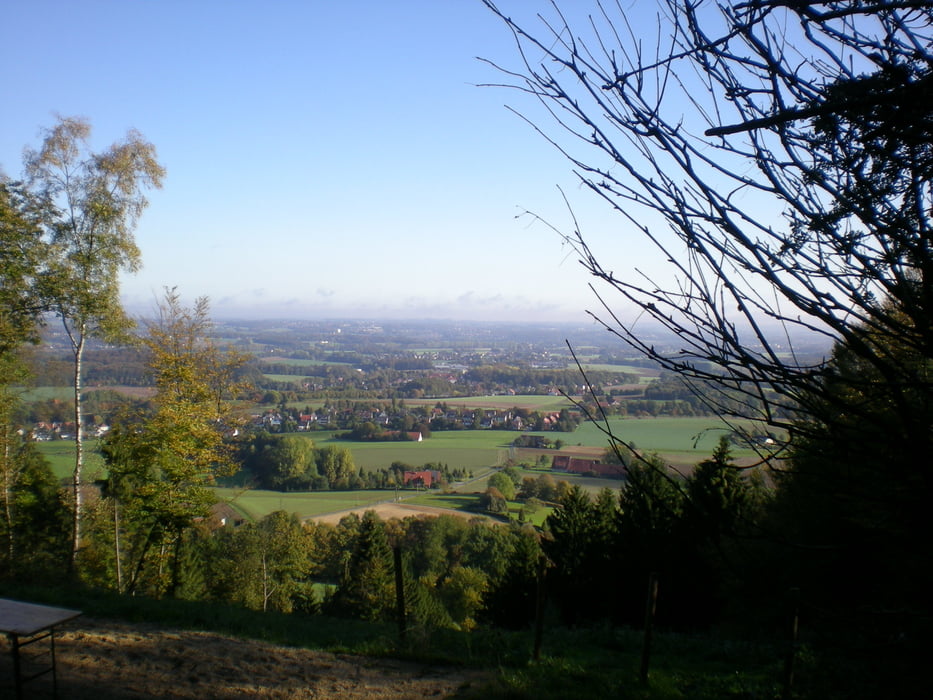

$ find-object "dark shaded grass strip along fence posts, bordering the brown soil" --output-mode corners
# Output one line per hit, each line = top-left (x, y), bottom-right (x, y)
(0, 584), (780, 700)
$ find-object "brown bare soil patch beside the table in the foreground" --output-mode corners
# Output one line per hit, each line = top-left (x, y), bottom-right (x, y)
(0, 618), (490, 700)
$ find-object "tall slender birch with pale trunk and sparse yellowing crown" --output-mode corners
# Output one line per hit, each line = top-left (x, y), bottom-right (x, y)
(25, 117), (165, 565)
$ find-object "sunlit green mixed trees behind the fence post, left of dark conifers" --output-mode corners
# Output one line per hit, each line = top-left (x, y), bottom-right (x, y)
(182, 511), (540, 629)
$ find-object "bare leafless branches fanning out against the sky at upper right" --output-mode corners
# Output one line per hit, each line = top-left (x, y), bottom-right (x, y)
(484, 0), (933, 460)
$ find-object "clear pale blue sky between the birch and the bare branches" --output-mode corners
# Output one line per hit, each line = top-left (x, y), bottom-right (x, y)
(0, 0), (654, 321)
